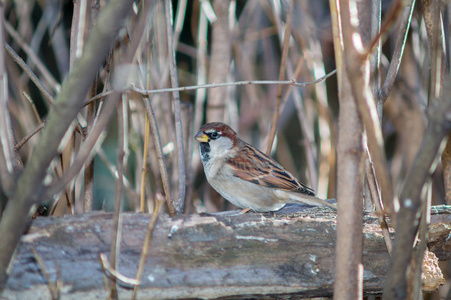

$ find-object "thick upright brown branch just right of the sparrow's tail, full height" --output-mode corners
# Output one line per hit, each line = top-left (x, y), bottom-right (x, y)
(329, 0), (364, 299)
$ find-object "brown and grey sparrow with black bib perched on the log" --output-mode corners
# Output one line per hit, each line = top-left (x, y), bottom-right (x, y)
(194, 122), (336, 212)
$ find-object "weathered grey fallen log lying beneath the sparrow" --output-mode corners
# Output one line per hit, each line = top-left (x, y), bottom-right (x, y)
(2, 207), (451, 299)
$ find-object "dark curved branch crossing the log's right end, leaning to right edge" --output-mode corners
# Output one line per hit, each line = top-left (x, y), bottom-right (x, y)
(384, 78), (451, 299)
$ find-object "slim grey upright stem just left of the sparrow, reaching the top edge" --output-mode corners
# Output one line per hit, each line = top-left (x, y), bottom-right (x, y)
(165, 0), (186, 214)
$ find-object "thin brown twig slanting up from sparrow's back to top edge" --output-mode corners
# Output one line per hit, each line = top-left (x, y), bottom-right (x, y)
(266, 0), (294, 155)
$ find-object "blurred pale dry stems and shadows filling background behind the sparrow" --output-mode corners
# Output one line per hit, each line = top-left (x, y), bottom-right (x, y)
(0, 0), (451, 297)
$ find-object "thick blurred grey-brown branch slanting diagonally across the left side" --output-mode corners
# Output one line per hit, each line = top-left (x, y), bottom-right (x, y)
(0, 0), (133, 291)
